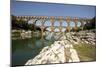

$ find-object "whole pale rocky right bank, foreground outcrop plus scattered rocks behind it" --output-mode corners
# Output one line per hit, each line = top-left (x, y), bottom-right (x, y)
(25, 30), (96, 65)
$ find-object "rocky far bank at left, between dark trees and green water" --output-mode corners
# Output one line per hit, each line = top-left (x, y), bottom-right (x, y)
(11, 30), (41, 40)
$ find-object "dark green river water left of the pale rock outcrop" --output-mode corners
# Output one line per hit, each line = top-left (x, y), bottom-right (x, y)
(12, 37), (53, 66)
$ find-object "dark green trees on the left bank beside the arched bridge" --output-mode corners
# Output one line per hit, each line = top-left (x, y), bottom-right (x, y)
(11, 15), (41, 31)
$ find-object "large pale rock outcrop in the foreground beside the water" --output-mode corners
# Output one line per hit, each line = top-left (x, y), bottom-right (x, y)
(25, 40), (80, 65)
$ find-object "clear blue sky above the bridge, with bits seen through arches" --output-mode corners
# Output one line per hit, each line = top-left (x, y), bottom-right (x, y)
(11, 0), (96, 31)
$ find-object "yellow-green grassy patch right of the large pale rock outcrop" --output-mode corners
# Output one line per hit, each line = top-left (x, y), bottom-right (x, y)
(73, 43), (96, 61)
